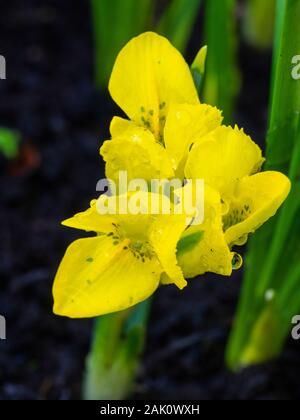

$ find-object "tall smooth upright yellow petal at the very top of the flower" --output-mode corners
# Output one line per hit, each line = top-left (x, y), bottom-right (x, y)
(109, 32), (199, 140)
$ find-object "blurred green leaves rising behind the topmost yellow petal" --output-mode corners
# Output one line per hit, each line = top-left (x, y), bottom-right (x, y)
(91, 0), (201, 89)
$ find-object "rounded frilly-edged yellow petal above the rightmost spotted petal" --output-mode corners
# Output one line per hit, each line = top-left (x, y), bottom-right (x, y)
(185, 126), (264, 198)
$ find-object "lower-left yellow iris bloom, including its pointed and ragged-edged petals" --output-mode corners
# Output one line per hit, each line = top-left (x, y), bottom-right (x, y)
(53, 193), (186, 318)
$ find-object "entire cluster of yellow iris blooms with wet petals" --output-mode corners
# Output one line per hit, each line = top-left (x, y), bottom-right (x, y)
(53, 33), (290, 317)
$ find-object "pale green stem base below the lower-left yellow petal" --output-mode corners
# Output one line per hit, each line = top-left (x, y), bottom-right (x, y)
(83, 300), (151, 400)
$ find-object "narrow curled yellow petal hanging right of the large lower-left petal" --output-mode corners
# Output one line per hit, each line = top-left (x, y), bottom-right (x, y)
(150, 214), (187, 289)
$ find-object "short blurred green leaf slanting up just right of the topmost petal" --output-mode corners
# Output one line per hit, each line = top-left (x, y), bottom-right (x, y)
(157, 0), (201, 52)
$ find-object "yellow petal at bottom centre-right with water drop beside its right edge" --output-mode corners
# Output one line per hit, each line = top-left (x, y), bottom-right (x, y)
(178, 185), (233, 278)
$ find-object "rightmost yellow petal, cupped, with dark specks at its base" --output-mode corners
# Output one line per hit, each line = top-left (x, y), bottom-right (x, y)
(224, 172), (291, 246)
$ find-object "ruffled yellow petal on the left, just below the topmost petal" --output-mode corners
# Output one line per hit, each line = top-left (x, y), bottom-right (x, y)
(100, 125), (174, 182)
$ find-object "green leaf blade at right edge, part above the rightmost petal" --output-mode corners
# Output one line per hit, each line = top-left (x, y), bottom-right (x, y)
(267, 0), (300, 173)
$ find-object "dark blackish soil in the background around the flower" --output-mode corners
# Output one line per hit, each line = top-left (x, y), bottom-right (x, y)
(0, 0), (300, 400)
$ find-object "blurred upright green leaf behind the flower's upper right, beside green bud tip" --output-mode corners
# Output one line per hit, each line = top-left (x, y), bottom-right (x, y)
(203, 0), (240, 123)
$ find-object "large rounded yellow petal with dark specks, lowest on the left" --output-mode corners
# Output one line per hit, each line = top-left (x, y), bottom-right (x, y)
(53, 237), (161, 318)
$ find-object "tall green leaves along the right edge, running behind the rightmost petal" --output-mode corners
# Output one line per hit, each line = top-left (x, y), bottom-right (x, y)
(226, 0), (300, 369)
